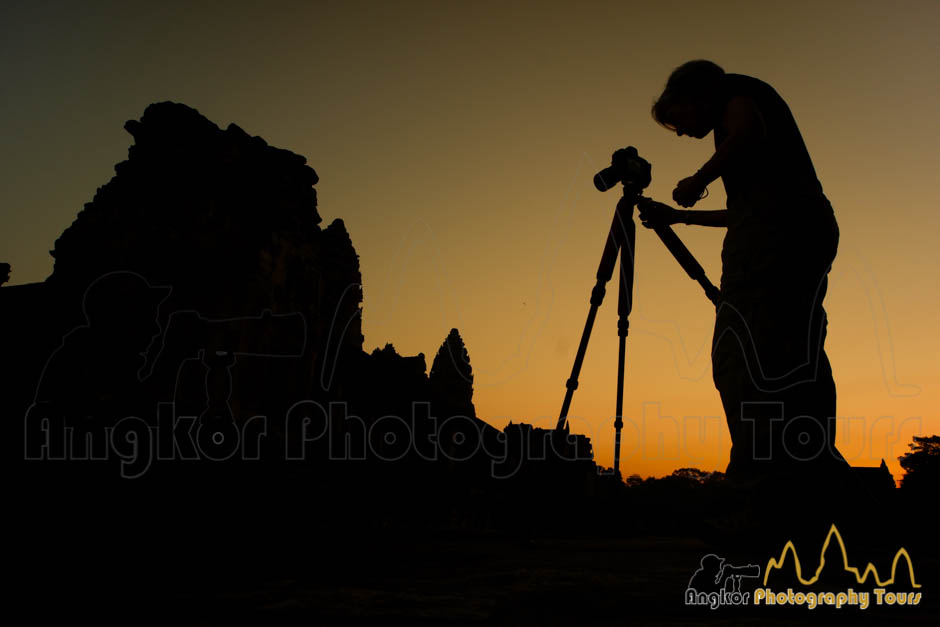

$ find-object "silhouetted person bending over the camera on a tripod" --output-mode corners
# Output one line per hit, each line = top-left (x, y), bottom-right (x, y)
(637, 60), (847, 486)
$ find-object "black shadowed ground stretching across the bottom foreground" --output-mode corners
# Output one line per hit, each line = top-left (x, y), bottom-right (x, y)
(14, 458), (940, 626)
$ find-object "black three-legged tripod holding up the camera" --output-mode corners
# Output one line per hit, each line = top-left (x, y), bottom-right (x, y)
(555, 184), (719, 476)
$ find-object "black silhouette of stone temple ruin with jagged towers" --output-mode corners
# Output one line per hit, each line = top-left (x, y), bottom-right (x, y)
(0, 102), (593, 506)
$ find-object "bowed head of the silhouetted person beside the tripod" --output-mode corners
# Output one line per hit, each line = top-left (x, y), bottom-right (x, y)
(652, 60), (725, 139)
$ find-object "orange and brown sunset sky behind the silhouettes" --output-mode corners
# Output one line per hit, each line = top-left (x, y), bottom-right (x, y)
(0, 0), (940, 478)
